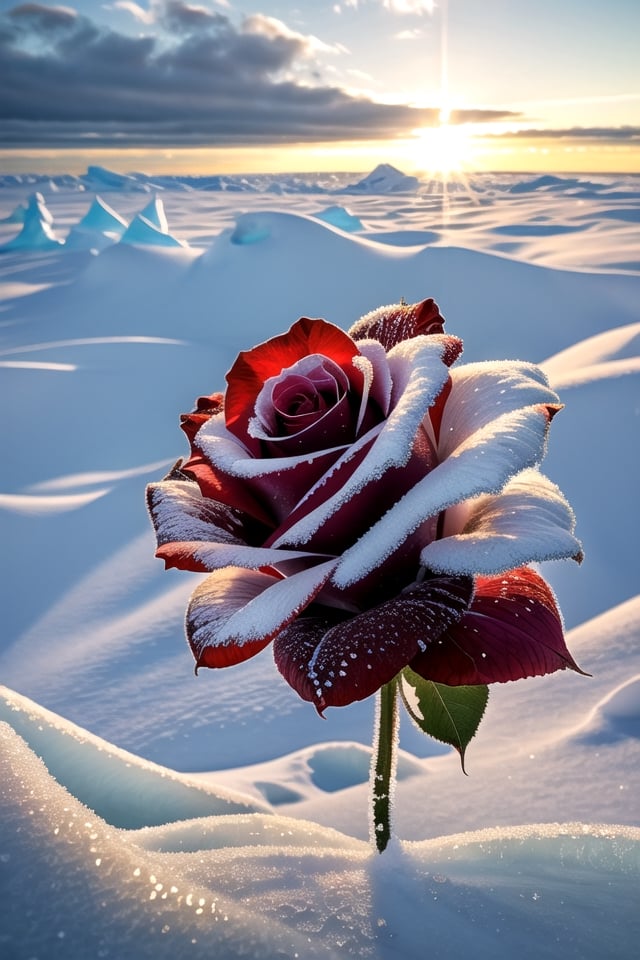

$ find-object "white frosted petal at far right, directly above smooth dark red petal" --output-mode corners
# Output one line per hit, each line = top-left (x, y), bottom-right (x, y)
(420, 470), (582, 574)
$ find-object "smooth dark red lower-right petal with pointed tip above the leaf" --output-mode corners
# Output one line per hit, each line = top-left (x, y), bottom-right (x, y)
(410, 567), (582, 686)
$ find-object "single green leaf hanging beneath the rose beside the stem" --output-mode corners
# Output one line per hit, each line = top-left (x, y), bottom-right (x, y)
(400, 667), (489, 773)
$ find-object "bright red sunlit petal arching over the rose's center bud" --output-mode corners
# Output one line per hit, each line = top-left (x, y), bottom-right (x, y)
(225, 317), (362, 443)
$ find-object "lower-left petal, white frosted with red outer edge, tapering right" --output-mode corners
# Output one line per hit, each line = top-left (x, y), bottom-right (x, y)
(187, 560), (336, 667)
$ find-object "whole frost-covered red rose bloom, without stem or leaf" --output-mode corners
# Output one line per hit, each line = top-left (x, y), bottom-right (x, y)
(148, 300), (580, 710)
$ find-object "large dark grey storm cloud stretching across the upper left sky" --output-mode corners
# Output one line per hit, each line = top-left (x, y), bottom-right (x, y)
(0, 0), (513, 147)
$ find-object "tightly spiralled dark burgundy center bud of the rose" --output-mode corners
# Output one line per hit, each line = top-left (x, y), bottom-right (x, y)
(255, 354), (355, 454)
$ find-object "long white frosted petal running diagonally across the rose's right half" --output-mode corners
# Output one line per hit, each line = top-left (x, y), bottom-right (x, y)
(333, 406), (553, 589)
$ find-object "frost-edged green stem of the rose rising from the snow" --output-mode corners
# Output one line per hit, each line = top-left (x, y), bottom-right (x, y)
(371, 680), (398, 853)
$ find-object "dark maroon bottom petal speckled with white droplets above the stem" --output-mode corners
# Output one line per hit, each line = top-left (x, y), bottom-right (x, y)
(273, 577), (473, 712)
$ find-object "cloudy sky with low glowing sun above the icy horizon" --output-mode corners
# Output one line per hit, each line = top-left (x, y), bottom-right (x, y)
(0, 0), (640, 175)
